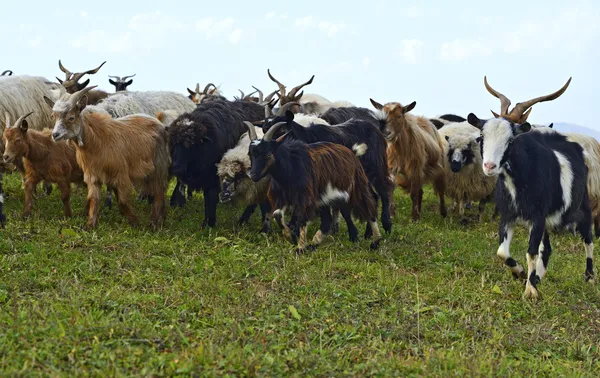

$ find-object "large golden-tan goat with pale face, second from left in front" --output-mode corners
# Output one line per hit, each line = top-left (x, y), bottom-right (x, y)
(44, 86), (169, 229)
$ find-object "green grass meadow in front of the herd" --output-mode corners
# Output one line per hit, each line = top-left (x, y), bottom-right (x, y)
(0, 174), (600, 377)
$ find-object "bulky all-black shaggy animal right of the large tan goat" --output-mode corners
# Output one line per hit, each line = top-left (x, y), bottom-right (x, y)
(168, 100), (262, 227)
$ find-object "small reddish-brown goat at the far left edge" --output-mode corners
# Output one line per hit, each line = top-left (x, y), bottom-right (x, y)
(2, 113), (83, 218)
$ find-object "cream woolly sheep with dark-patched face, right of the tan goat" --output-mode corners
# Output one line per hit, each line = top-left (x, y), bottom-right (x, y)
(439, 122), (496, 223)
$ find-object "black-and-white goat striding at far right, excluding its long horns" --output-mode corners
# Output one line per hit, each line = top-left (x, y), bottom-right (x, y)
(468, 113), (594, 298)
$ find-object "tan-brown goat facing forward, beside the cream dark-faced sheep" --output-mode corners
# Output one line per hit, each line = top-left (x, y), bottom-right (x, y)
(371, 99), (447, 222)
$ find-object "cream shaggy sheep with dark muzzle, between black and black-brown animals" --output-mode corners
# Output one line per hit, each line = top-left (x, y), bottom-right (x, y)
(217, 121), (272, 233)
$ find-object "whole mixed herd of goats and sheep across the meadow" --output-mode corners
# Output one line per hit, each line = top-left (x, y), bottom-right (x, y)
(0, 61), (600, 298)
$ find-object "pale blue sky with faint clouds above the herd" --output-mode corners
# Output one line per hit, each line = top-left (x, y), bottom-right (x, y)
(0, 0), (600, 130)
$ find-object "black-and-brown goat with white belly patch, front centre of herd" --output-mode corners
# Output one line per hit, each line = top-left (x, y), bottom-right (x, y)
(246, 122), (381, 253)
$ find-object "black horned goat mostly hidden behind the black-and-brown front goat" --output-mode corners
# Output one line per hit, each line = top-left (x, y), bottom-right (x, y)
(263, 102), (393, 237)
